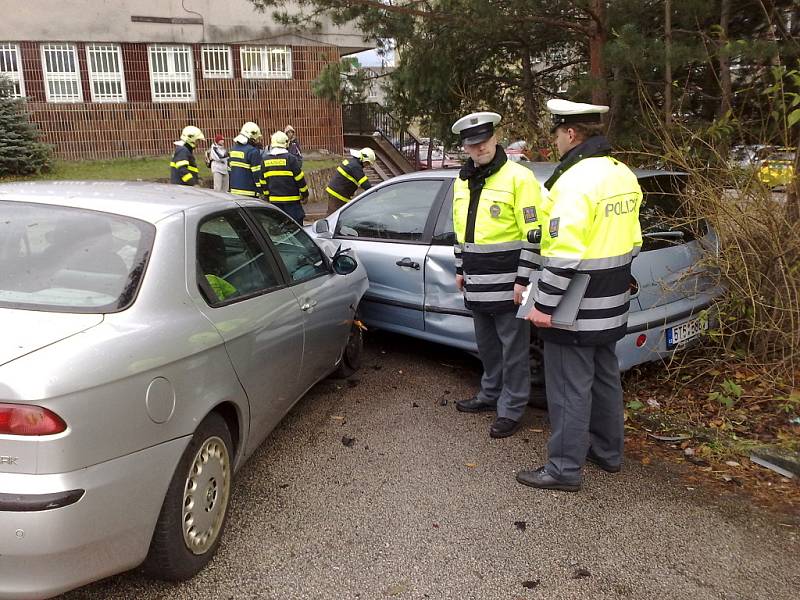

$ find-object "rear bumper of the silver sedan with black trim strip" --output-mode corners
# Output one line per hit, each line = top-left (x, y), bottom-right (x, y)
(0, 437), (191, 600)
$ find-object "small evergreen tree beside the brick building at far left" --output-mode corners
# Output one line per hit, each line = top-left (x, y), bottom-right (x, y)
(0, 78), (53, 177)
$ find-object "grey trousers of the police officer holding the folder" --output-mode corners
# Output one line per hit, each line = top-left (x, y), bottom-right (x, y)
(544, 342), (624, 483)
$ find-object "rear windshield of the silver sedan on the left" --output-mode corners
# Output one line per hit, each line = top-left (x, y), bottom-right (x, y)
(0, 202), (155, 313)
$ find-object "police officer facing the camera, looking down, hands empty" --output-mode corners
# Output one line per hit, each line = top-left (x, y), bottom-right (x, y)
(452, 112), (541, 438)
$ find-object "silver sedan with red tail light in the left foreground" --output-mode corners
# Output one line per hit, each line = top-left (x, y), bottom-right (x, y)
(0, 182), (367, 598)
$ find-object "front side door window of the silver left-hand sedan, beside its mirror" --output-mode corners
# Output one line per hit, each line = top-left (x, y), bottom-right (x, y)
(248, 210), (330, 281)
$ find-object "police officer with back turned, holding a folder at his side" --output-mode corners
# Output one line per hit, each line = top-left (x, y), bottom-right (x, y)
(517, 100), (642, 492)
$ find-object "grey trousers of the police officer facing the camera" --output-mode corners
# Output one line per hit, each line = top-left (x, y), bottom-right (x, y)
(472, 310), (531, 421)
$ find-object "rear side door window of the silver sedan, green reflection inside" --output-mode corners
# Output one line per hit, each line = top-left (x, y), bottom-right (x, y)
(197, 211), (280, 306)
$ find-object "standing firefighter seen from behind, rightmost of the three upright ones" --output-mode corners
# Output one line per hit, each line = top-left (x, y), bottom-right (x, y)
(263, 131), (308, 225)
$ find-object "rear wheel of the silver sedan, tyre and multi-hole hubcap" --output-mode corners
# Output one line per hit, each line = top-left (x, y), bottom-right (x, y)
(142, 413), (233, 581)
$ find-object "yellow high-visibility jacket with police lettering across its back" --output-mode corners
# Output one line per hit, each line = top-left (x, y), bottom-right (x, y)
(534, 156), (642, 346)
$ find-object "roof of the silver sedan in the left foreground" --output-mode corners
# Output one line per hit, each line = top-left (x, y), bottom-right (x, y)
(0, 181), (263, 223)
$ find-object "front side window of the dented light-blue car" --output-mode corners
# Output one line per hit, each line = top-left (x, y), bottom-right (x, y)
(336, 179), (442, 241)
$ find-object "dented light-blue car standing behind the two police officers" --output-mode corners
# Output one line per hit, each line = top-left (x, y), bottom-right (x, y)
(307, 162), (721, 382)
